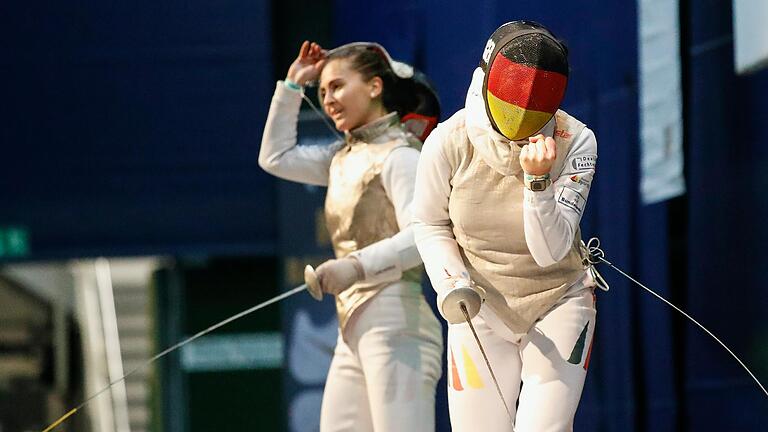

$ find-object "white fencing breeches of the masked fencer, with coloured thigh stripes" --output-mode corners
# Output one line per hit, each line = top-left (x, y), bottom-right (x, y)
(447, 282), (596, 432)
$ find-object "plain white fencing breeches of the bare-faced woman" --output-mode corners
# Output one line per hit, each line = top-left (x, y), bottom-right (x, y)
(320, 284), (443, 432)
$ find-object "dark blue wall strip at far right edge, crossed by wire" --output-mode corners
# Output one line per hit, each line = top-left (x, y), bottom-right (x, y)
(684, 1), (768, 431)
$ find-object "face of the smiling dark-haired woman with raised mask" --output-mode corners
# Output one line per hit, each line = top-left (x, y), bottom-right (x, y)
(320, 59), (384, 132)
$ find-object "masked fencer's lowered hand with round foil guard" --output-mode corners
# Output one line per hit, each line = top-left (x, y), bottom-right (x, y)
(437, 276), (485, 324)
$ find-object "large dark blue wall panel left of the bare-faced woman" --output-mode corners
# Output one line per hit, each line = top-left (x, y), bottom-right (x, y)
(0, 0), (275, 258)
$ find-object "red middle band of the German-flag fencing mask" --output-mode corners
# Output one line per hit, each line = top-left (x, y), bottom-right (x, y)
(488, 55), (568, 113)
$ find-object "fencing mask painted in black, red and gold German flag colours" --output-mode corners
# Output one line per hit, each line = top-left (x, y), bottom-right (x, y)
(480, 21), (568, 141)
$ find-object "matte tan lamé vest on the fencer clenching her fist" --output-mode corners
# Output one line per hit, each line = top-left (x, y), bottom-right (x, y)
(446, 111), (585, 333)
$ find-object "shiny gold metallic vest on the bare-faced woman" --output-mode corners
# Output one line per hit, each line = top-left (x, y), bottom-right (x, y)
(325, 113), (422, 329)
